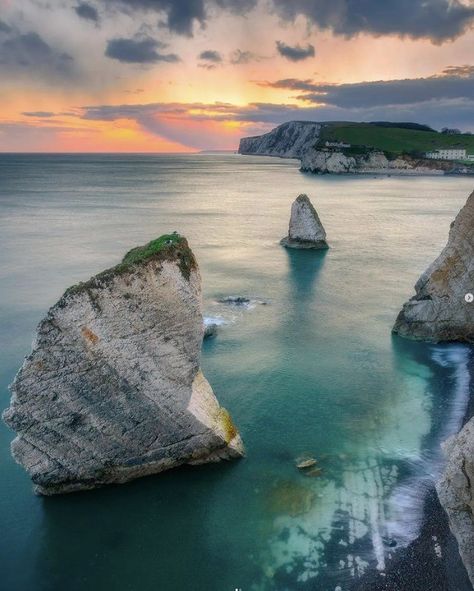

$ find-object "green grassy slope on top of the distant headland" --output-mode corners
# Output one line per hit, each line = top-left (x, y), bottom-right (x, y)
(318, 122), (474, 154)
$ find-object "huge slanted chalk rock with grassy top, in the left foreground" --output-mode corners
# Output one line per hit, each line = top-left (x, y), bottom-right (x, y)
(4, 234), (243, 495)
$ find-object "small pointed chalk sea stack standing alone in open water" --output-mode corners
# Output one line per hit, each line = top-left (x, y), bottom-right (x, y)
(280, 195), (329, 249)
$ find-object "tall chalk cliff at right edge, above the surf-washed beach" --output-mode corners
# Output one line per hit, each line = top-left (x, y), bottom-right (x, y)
(393, 192), (474, 342)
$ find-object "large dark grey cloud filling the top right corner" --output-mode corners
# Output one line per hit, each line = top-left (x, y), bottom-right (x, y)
(272, 0), (474, 43)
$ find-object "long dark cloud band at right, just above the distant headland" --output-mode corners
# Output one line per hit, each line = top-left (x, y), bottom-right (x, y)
(263, 66), (474, 109)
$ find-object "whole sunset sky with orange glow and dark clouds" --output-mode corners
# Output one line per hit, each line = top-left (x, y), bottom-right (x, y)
(0, 0), (474, 152)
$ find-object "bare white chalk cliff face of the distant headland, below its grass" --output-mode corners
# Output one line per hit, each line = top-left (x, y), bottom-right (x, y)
(239, 121), (473, 175)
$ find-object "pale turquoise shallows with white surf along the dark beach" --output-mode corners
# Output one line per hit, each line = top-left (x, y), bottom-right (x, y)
(254, 343), (469, 591)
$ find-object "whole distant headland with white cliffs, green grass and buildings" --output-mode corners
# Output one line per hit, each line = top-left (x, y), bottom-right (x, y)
(239, 121), (474, 175)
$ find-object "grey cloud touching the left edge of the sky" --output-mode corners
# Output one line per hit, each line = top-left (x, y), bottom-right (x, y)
(0, 23), (73, 76)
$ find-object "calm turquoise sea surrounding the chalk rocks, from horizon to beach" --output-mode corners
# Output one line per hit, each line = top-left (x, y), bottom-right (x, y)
(0, 155), (472, 591)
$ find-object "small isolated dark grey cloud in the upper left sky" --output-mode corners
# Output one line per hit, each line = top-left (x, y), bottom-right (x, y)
(105, 36), (180, 64)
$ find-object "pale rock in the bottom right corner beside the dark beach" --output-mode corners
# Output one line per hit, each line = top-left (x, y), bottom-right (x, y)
(436, 419), (474, 586)
